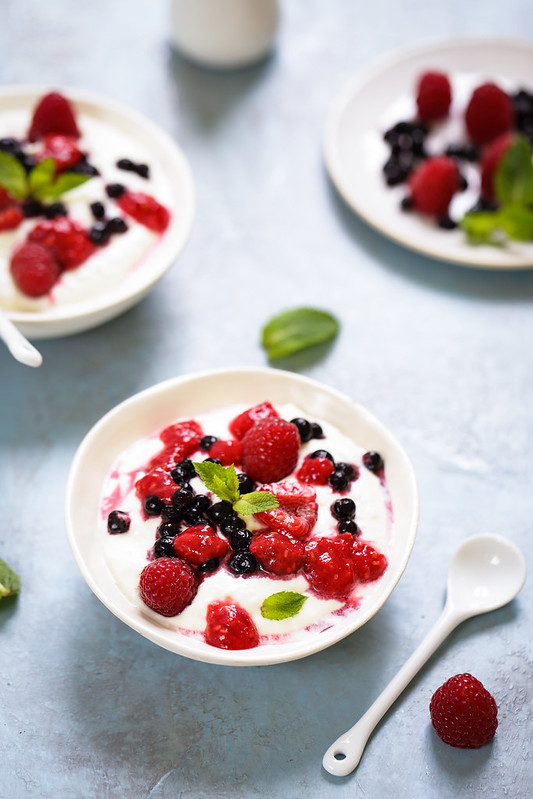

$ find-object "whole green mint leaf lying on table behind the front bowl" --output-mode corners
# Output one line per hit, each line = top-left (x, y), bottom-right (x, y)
(261, 308), (339, 359)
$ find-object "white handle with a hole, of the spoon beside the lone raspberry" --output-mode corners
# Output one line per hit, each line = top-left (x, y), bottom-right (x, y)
(322, 605), (464, 777)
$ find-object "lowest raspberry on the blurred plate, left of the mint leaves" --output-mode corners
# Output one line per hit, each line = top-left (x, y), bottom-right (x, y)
(409, 155), (459, 216)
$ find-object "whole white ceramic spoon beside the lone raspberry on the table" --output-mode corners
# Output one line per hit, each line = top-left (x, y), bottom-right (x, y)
(322, 535), (526, 777)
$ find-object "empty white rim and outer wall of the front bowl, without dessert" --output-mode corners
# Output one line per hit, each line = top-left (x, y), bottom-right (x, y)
(66, 368), (418, 666)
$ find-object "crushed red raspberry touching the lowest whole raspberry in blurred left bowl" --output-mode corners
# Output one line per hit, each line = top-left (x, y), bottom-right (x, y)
(28, 216), (96, 269)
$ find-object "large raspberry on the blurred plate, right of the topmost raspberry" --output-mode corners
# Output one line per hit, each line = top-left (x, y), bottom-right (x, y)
(465, 83), (514, 144)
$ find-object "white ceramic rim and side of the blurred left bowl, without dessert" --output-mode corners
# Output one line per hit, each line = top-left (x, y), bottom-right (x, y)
(0, 86), (195, 339)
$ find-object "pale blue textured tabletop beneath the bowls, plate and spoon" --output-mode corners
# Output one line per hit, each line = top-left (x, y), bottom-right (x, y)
(0, 0), (533, 799)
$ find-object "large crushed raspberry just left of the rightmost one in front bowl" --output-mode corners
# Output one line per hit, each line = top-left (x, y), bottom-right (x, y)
(304, 536), (357, 597)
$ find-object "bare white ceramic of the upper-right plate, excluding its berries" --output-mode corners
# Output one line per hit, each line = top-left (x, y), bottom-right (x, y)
(323, 39), (533, 269)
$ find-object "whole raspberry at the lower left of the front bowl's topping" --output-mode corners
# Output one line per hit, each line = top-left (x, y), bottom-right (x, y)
(139, 558), (198, 616)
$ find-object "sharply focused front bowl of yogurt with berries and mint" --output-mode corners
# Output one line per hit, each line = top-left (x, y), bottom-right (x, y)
(66, 368), (418, 666)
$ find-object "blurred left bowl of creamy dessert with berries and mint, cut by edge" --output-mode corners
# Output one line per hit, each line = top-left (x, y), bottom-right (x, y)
(0, 86), (194, 338)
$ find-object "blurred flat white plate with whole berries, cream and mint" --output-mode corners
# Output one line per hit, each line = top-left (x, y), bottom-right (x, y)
(323, 39), (533, 269)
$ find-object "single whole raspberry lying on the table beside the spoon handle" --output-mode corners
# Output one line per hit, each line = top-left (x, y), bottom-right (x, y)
(429, 673), (498, 749)
